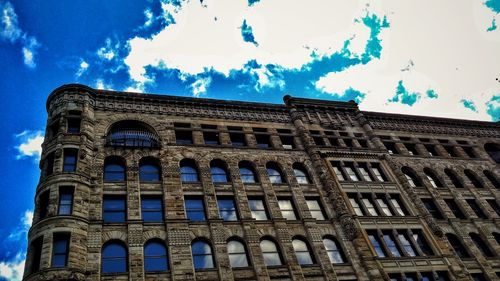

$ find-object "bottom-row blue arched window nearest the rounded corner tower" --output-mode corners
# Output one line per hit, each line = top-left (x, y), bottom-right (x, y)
(101, 240), (128, 273)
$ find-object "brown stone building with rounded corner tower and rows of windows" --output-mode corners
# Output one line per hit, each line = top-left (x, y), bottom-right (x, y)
(24, 84), (500, 281)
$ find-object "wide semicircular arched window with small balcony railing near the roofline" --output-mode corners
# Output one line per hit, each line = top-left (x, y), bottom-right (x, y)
(106, 120), (160, 148)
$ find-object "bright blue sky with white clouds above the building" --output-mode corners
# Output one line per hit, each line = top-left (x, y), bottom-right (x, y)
(0, 0), (500, 280)
